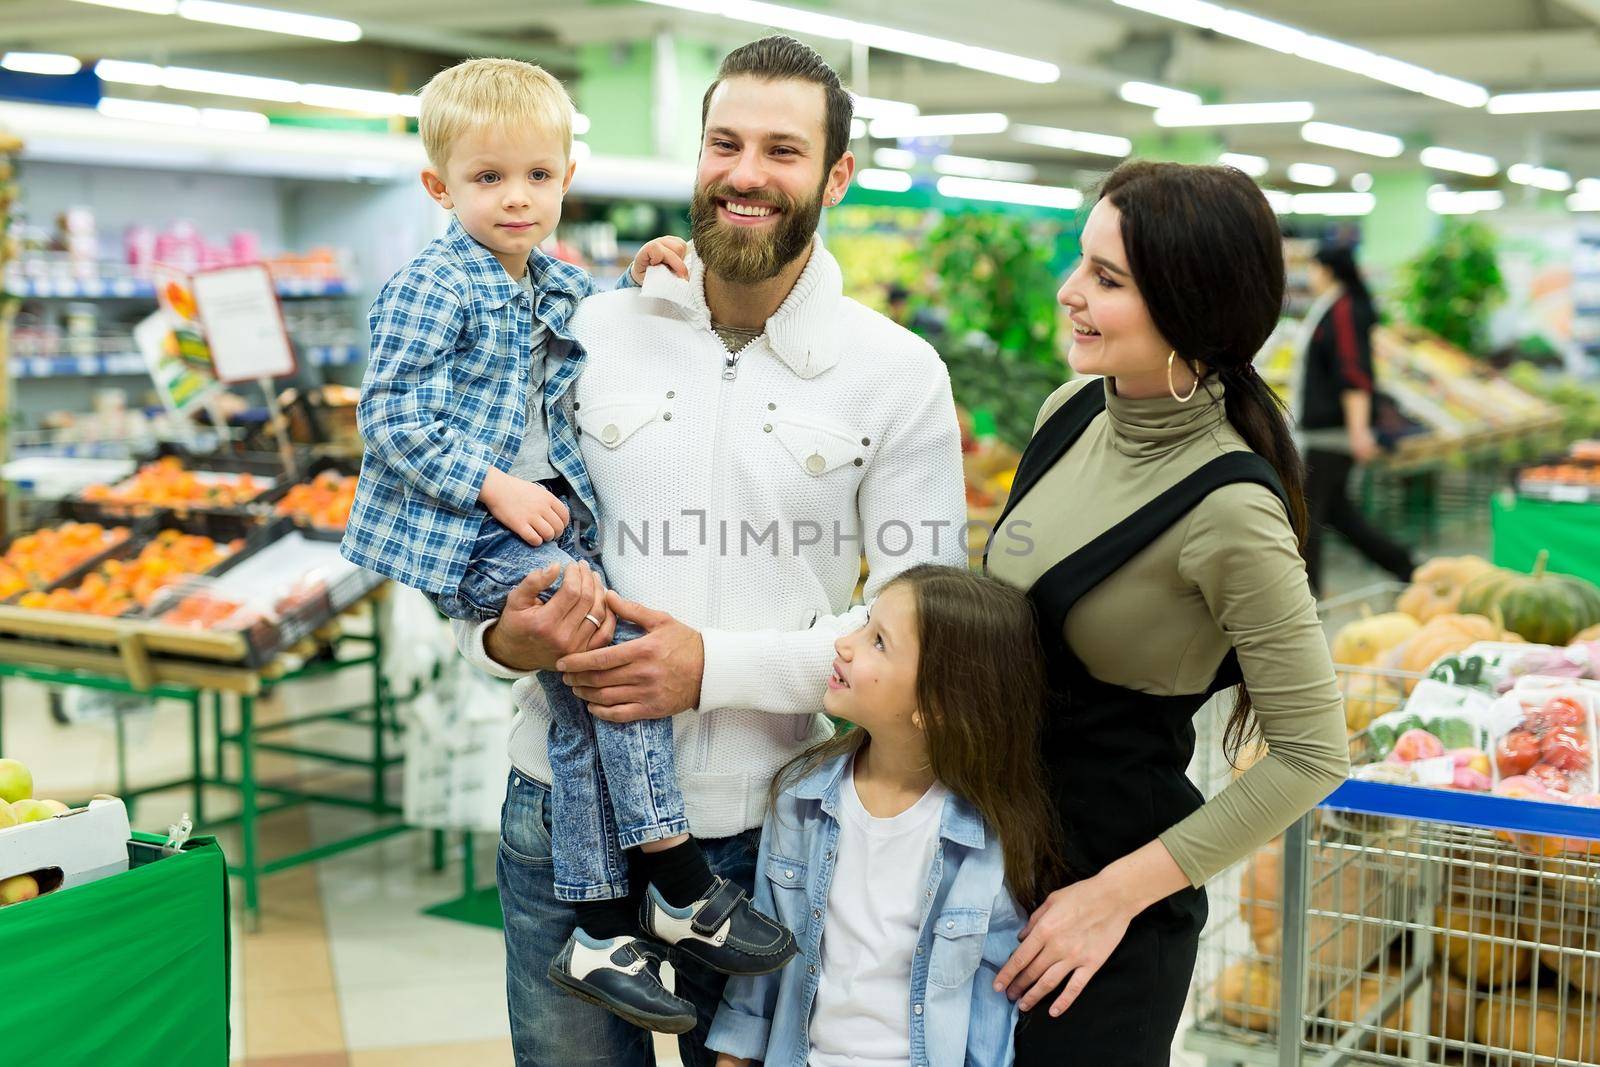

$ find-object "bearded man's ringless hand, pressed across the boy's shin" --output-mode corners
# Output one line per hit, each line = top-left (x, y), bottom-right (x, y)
(555, 592), (706, 723)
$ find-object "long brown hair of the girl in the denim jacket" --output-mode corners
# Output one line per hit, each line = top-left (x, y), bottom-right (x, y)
(773, 563), (1066, 910)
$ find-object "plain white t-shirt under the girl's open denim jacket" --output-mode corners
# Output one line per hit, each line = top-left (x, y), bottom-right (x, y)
(808, 760), (949, 1067)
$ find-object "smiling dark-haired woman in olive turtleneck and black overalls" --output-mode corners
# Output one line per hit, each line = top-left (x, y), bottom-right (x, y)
(987, 163), (1349, 1067)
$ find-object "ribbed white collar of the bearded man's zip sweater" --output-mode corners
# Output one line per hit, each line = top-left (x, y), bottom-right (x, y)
(642, 237), (845, 378)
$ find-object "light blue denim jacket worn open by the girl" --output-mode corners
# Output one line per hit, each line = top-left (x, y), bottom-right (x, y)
(706, 755), (1024, 1067)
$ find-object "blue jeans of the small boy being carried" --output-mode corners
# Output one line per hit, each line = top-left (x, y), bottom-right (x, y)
(432, 483), (690, 901)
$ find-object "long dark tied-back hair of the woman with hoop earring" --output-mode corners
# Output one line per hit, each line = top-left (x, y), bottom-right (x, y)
(1099, 162), (1306, 760)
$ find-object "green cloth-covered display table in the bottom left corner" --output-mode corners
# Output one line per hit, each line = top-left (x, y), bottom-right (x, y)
(0, 833), (230, 1067)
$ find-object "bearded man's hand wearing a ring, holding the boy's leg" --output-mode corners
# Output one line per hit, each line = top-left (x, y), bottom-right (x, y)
(483, 560), (616, 670)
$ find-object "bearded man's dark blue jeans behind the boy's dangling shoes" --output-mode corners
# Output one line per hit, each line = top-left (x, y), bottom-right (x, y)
(494, 771), (760, 1067)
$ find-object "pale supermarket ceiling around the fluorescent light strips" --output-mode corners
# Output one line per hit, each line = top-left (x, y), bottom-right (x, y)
(0, 0), (1600, 186)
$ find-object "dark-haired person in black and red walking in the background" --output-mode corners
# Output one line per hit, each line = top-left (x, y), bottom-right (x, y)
(1298, 245), (1416, 592)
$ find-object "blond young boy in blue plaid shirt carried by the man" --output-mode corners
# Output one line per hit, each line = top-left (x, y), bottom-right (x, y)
(342, 59), (795, 1033)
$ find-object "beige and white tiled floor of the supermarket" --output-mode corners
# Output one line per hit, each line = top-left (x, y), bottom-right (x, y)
(5, 511), (1465, 1067)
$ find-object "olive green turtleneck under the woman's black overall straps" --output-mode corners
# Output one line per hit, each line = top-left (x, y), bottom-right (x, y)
(989, 379), (1349, 886)
